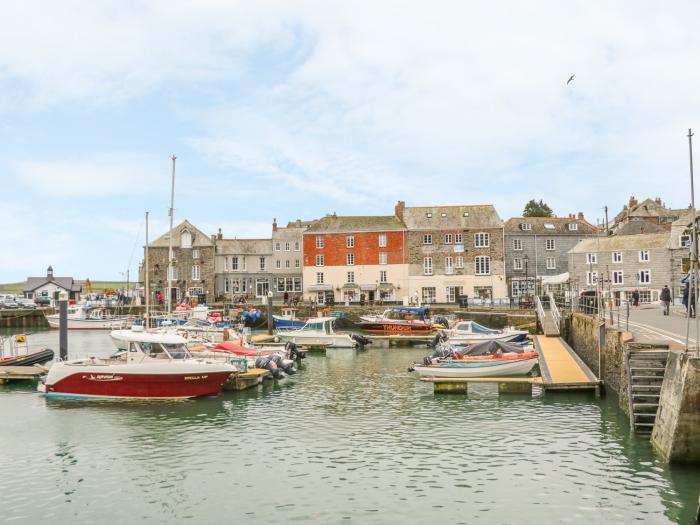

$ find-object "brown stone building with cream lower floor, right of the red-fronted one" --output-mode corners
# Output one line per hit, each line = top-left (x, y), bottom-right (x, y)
(395, 201), (508, 304)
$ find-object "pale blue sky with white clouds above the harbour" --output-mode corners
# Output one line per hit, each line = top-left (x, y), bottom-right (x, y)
(0, 0), (700, 282)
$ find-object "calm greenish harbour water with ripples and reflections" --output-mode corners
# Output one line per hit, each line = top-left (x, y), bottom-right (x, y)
(0, 333), (700, 525)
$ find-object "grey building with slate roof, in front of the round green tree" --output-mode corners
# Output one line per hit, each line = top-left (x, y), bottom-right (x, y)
(504, 213), (600, 298)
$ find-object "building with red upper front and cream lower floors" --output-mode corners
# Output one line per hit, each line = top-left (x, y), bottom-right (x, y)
(303, 213), (408, 304)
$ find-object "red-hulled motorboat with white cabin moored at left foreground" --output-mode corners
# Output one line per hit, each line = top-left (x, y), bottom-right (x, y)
(39, 331), (237, 400)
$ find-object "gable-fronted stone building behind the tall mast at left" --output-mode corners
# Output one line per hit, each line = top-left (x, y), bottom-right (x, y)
(144, 220), (215, 304)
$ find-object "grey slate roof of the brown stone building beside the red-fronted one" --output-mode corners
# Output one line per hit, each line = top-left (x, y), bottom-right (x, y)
(403, 204), (503, 230)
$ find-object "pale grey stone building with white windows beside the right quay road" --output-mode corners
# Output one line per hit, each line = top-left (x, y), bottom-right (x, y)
(569, 233), (682, 304)
